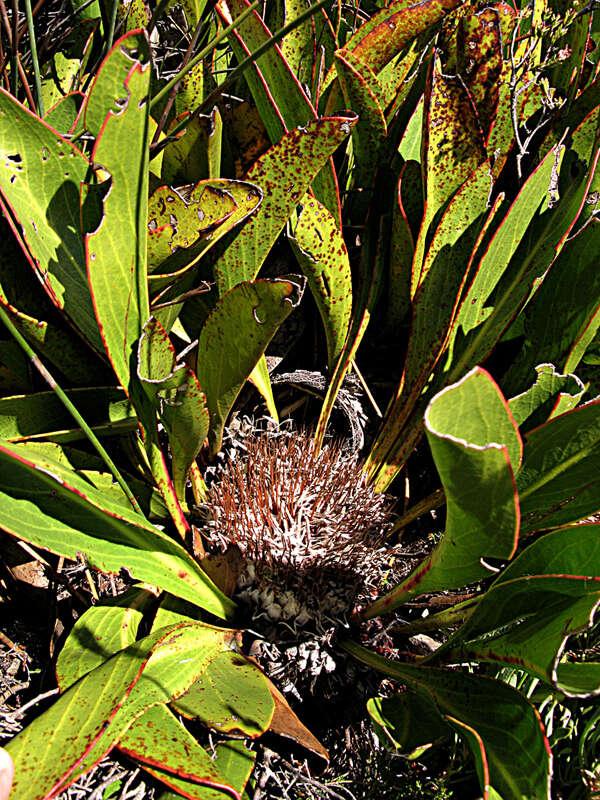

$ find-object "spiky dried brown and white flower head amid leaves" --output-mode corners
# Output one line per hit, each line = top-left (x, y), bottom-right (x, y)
(209, 430), (390, 627)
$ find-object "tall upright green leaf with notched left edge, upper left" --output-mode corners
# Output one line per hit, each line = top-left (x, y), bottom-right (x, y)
(85, 34), (150, 394)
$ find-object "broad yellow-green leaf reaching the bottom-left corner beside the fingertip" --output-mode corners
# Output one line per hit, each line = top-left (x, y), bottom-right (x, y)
(7, 624), (224, 797)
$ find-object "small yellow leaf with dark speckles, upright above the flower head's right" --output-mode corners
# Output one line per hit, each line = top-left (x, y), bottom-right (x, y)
(289, 195), (352, 370)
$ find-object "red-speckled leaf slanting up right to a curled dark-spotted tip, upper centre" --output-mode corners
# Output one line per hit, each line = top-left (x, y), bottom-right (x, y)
(214, 113), (356, 294)
